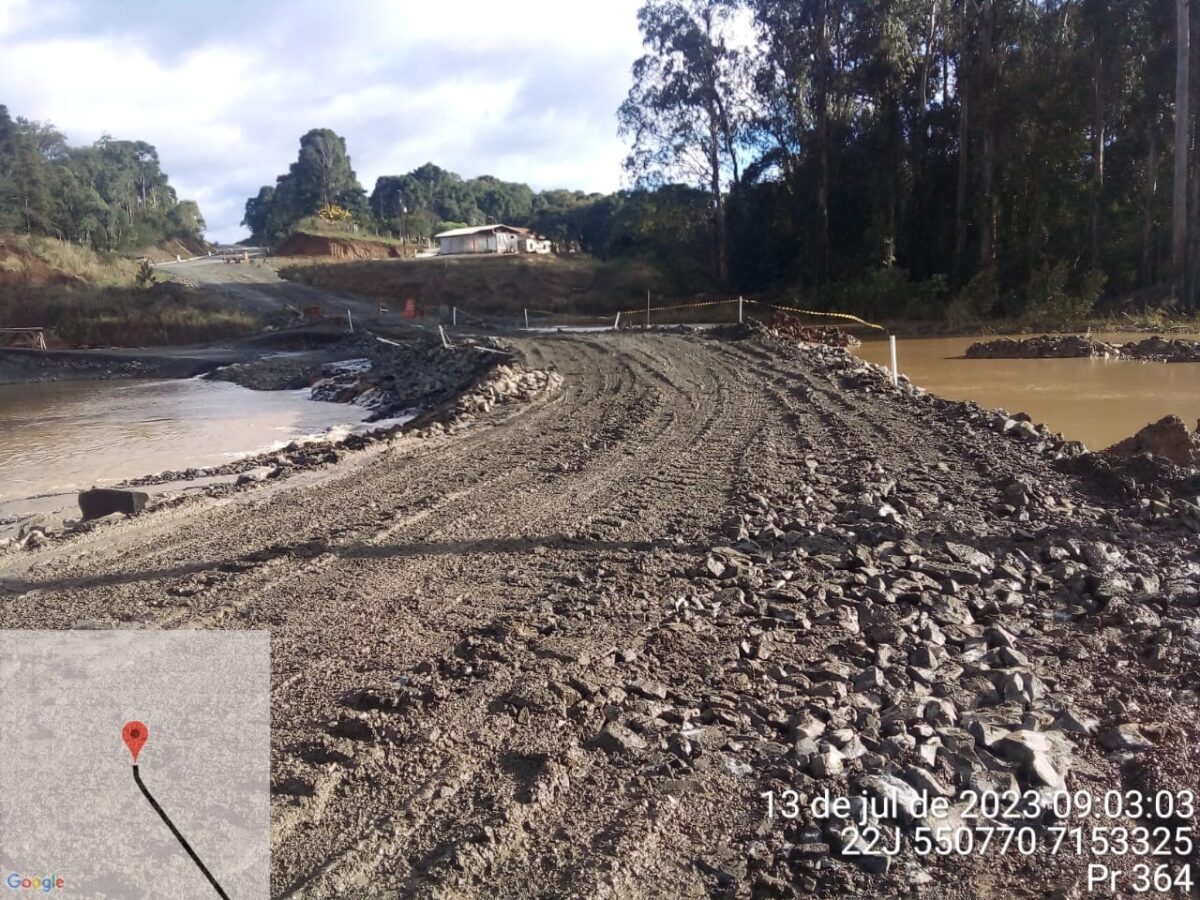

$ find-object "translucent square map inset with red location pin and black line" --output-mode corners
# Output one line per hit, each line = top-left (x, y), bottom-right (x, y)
(0, 631), (270, 900)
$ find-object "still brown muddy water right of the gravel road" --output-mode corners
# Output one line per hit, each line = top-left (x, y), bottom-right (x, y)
(857, 334), (1200, 450)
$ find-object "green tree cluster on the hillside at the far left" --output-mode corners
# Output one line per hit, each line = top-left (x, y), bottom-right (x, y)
(0, 104), (204, 251)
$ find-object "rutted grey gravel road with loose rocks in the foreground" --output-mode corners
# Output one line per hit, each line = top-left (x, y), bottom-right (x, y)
(0, 335), (1200, 898)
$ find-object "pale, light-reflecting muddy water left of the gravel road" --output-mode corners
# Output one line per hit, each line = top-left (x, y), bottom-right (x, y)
(0, 379), (367, 505)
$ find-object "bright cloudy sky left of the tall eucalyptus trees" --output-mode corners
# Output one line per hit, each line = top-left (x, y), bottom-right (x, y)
(0, 0), (641, 240)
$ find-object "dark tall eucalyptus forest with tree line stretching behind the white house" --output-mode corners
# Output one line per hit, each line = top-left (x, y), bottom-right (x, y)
(246, 0), (1200, 319)
